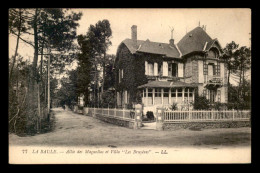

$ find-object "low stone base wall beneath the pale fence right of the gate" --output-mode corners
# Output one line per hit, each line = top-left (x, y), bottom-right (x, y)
(163, 121), (251, 130)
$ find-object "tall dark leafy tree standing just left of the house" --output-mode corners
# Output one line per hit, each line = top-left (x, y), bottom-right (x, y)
(78, 20), (115, 106)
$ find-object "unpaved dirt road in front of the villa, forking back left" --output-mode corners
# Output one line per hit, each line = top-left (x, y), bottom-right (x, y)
(9, 108), (251, 148)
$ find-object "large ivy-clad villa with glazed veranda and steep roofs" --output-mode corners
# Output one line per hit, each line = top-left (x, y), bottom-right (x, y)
(114, 25), (227, 111)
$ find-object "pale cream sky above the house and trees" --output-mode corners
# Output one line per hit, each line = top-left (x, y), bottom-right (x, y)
(9, 8), (251, 83)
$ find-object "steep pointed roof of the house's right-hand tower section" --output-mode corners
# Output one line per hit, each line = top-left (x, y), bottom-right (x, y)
(177, 27), (213, 55)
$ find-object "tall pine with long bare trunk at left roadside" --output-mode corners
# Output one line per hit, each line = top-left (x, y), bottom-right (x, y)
(9, 8), (82, 134)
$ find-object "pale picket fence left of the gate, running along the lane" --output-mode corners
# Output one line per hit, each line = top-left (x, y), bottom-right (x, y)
(88, 108), (135, 120)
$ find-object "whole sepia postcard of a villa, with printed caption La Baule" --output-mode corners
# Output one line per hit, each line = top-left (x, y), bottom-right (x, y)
(8, 8), (251, 164)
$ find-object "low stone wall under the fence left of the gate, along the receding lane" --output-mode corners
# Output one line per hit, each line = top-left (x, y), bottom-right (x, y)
(95, 114), (134, 129)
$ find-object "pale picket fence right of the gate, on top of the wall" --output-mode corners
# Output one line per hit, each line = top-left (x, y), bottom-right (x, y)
(163, 110), (251, 122)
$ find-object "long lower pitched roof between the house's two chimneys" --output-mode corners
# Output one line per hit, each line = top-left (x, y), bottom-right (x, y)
(122, 39), (180, 58)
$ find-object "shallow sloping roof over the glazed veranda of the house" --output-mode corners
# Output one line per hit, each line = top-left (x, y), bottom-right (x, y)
(138, 81), (197, 88)
